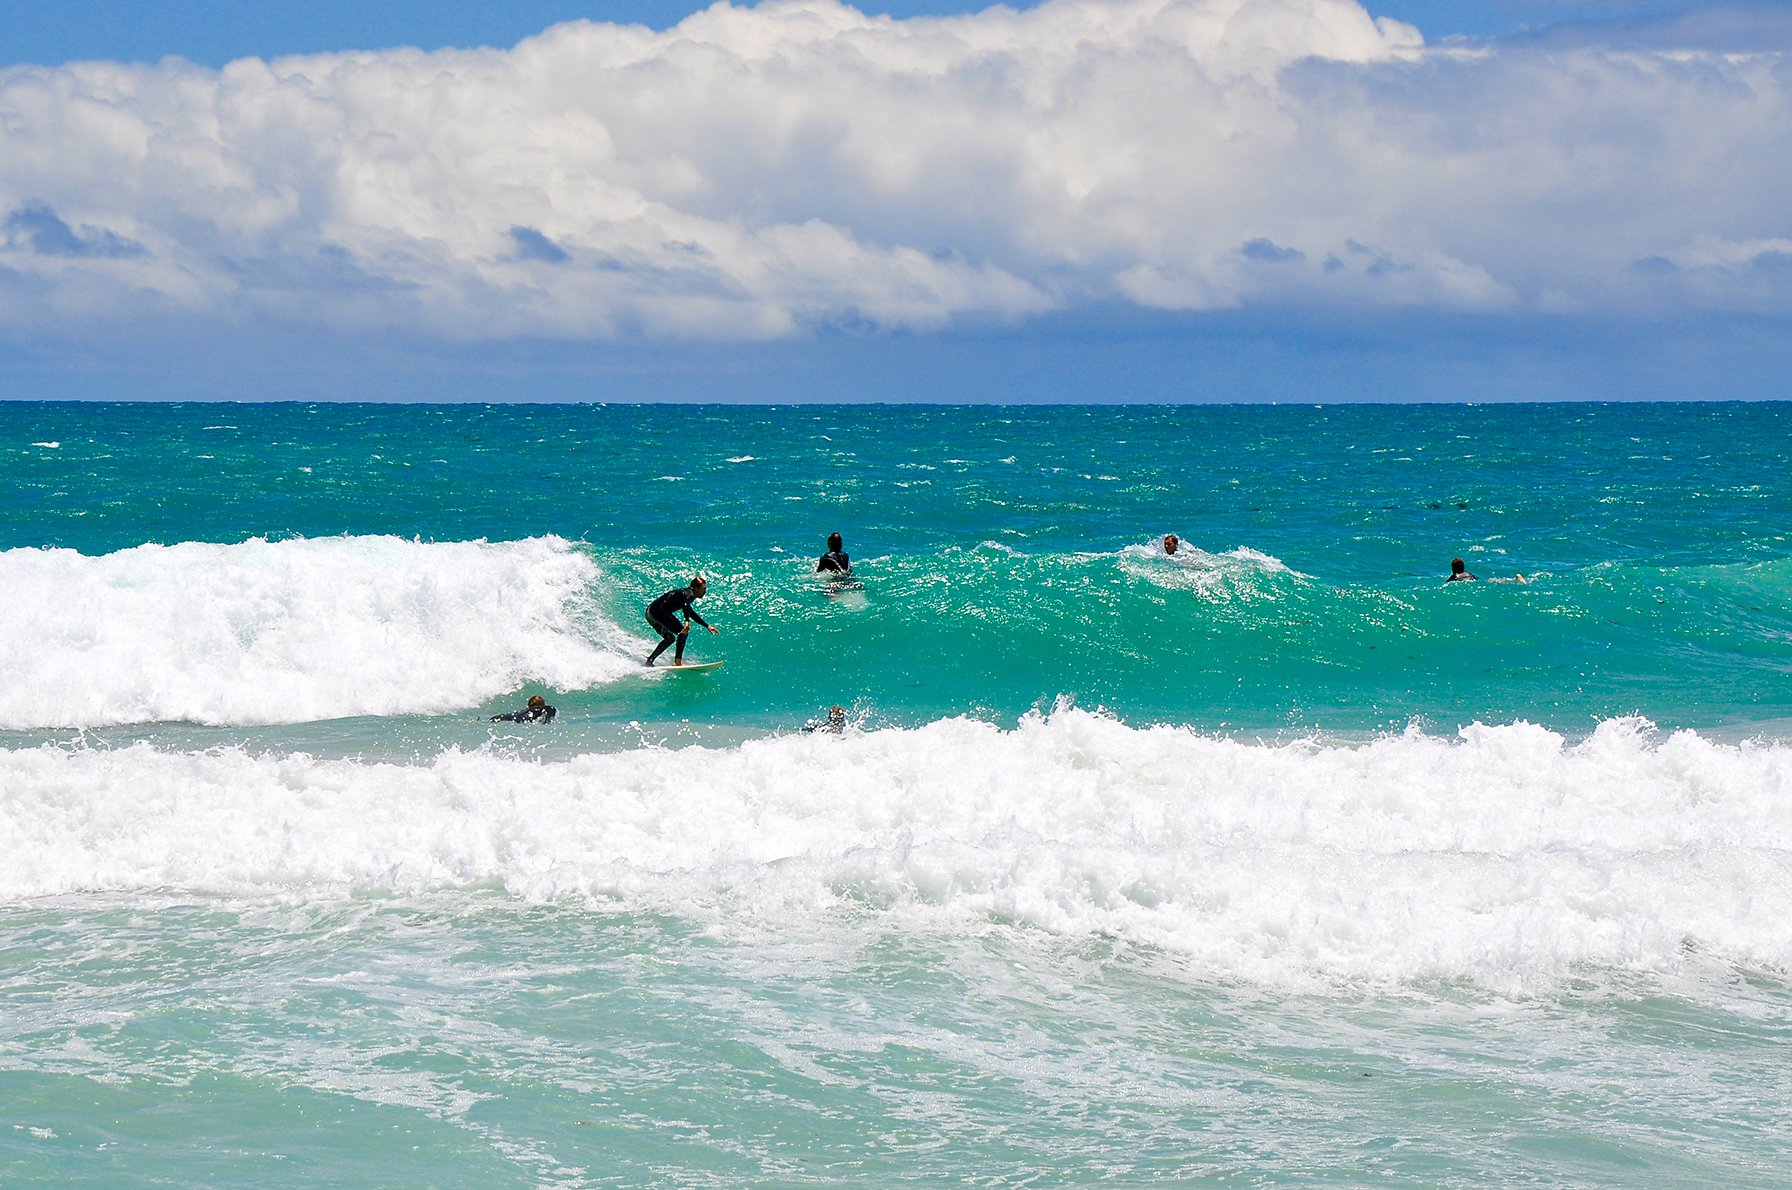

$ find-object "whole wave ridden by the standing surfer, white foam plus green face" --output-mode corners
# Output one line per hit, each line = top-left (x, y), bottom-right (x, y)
(14, 536), (1792, 744)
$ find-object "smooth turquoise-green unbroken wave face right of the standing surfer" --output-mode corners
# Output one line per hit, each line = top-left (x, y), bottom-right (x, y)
(584, 541), (1792, 733)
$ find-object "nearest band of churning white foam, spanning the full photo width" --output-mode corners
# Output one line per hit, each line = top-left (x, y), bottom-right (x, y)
(0, 710), (1792, 989)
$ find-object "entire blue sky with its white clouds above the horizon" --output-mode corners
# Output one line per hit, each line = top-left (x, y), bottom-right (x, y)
(0, 0), (1792, 401)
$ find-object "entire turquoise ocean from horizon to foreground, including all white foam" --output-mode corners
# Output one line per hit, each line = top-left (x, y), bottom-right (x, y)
(0, 403), (1792, 1188)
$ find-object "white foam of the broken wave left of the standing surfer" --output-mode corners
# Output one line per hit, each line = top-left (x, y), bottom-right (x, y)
(0, 538), (633, 729)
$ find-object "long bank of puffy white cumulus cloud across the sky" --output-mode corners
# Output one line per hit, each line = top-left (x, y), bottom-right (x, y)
(0, 0), (1792, 341)
